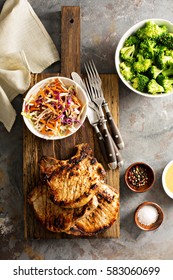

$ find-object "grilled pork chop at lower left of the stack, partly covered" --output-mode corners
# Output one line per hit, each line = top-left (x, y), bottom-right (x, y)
(28, 186), (98, 232)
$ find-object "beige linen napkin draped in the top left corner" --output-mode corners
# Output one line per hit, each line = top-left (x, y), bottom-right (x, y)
(0, 0), (59, 131)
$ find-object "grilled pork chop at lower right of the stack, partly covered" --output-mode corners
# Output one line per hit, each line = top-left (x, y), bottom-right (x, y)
(66, 184), (119, 236)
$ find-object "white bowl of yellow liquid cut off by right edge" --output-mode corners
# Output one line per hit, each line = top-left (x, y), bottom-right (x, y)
(162, 160), (173, 199)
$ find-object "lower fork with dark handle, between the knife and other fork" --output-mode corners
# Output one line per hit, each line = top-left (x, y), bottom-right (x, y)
(83, 75), (117, 169)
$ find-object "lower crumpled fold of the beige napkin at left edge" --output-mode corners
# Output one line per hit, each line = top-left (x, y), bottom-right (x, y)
(0, 51), (31, 131)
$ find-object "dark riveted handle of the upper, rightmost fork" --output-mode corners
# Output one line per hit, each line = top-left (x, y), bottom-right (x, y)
(103, 102), (124, 150)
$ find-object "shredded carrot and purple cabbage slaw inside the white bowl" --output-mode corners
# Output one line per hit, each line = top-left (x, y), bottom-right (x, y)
(24, 78), (83, 136)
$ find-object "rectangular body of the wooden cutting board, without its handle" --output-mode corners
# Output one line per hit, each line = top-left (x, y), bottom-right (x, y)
(23, 74), (120, 239)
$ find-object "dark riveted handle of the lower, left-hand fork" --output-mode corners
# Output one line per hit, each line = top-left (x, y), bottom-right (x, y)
(101, 120), (117, 169)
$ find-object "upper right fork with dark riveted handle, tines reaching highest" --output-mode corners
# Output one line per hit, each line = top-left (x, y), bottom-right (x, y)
(84, 60), (124, 149)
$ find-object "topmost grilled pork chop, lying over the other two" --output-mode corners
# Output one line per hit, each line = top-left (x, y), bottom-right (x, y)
(40, 144), (106, 208)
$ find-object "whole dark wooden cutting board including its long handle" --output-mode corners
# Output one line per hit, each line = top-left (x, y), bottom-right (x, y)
(23, 6), (120, 239)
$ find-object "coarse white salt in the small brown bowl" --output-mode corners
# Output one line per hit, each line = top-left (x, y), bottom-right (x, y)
(138, 205), (159, 226)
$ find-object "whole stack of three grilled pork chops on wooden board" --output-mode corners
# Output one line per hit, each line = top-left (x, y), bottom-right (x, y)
(28, 144), (119, 236)
